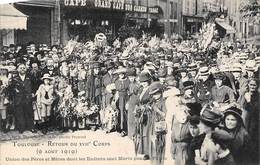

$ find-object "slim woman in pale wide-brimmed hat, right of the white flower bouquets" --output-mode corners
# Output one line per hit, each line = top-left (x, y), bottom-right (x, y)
(114, 68), (130, 136)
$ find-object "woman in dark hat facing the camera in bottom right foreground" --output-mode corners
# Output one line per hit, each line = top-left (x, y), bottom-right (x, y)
(220, 107), (250, 165)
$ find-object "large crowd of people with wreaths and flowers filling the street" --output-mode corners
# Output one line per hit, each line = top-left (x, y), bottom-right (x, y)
(0, 26), (260, 165)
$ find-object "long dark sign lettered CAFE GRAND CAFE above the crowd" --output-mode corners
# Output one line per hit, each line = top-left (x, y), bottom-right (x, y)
(63, 0), (159, 14)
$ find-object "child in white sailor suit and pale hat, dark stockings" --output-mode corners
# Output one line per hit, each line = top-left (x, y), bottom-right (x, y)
(36, 74), (54, 134)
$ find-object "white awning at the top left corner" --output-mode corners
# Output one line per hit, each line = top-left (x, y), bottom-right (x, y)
(0, 4), (28, 30)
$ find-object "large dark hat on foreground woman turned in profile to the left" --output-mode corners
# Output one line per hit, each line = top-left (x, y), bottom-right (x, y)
(200, 104), (223, 126)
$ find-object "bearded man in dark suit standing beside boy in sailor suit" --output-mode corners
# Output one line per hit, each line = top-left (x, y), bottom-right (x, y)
(10, 63), (36, 133)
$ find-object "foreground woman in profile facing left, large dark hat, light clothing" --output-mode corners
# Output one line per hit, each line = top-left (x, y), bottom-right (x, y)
(195, 105), (235, 165)
